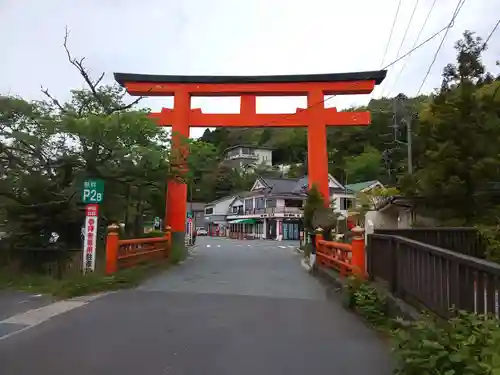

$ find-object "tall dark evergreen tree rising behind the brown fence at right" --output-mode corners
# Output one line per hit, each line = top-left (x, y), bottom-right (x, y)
(404, 31), (500, 225)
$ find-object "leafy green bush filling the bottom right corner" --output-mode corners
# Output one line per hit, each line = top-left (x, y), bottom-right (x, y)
(394, 312), (500, 375)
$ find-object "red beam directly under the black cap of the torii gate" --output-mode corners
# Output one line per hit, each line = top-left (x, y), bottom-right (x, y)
(124, 80), (375, 97)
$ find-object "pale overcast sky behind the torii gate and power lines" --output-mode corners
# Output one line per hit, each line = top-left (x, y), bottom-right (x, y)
(0, 0), (500, 136)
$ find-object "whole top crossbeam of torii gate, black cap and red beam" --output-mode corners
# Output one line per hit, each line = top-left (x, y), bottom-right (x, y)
(114, 70), (387, 96)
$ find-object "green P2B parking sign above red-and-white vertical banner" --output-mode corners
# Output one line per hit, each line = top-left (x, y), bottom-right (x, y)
(82, 179), (104, 273)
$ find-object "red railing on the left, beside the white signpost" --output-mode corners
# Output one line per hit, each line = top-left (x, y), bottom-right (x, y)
(106, 225), (172, 275)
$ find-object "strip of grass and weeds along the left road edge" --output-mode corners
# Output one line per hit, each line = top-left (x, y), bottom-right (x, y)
(0, 259), (171, 298)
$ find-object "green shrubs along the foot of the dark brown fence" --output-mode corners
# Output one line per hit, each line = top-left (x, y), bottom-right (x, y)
(344, 277), (500, 375)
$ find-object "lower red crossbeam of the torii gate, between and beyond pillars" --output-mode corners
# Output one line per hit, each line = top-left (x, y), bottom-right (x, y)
(149, 107), (371, 128)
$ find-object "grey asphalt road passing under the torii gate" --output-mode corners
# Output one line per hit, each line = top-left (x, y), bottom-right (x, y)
(0, 238), (391, 375)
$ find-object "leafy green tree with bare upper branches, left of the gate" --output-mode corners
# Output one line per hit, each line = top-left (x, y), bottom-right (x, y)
(0, 27), (171, 247)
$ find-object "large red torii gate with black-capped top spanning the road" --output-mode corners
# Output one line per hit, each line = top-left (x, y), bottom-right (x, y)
(114, 70), (387, 247)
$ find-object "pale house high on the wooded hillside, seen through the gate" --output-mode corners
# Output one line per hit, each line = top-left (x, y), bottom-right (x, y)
(224, 145), (273, 169)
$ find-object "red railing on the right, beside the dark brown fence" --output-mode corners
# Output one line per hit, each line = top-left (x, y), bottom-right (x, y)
(316, 227), (366, 277)
